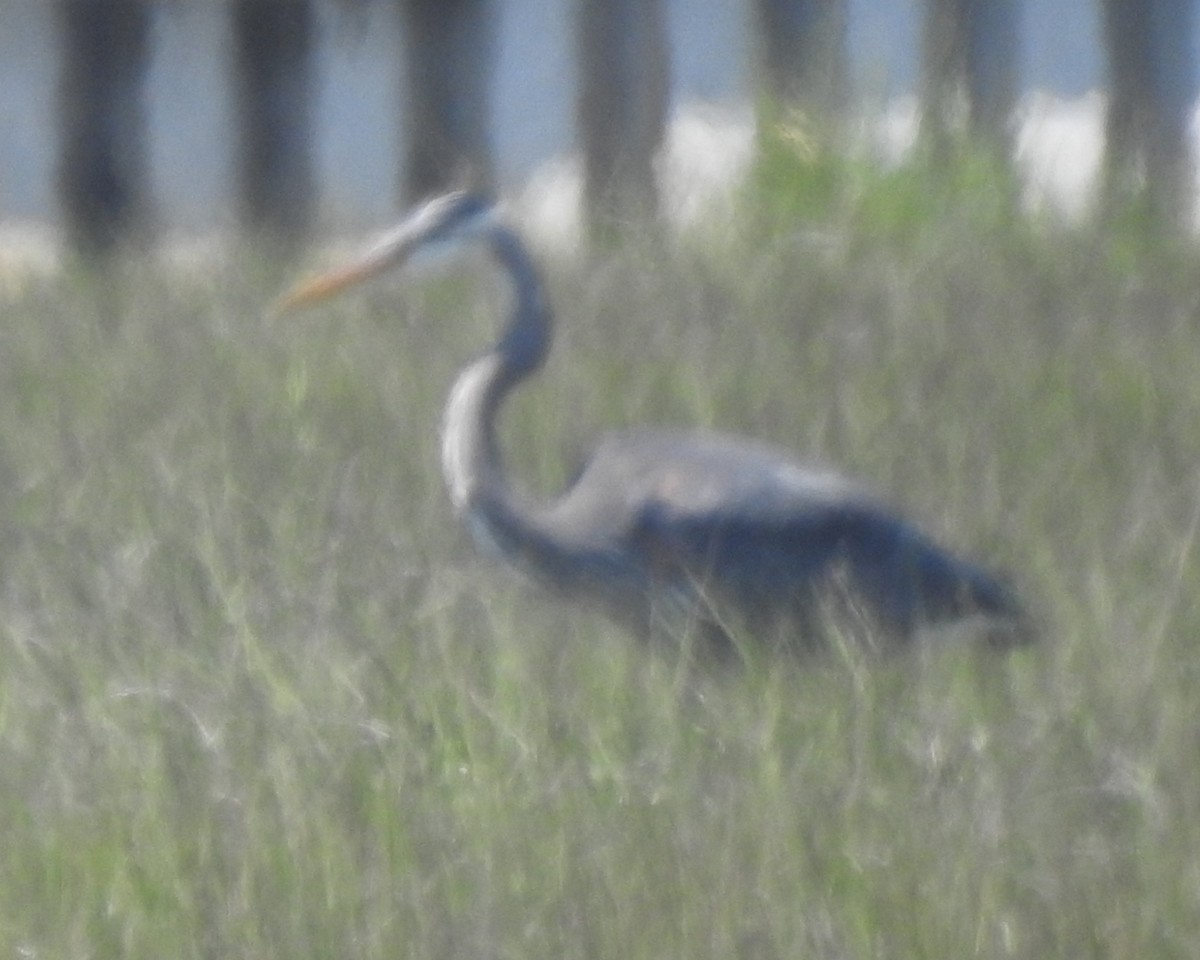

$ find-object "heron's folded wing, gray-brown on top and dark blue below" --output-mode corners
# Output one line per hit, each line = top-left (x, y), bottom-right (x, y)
(546, 431), (1015, 632)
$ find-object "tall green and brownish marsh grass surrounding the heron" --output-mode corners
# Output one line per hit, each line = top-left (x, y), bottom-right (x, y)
(0, 160), (1200, 960)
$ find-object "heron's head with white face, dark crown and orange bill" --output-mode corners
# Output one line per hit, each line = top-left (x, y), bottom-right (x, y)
(276, 192), (497, 312)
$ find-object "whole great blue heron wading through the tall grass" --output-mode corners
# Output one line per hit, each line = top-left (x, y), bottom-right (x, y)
(282, 193), (1026, 649)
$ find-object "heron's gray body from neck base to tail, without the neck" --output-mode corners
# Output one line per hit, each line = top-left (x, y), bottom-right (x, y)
(466, 430), (1021, 649)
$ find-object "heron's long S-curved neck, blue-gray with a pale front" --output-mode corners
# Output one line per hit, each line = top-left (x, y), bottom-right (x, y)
(442, 228), (551, 553)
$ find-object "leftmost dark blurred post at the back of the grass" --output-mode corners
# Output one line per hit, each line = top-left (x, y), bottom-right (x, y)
(56, 0), (150, 256)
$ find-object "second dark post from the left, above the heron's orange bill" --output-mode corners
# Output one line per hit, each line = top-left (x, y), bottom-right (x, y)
(232, 0), (316, 242)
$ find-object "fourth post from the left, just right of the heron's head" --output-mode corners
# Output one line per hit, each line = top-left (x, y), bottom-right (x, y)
(578, 0), (670, 234)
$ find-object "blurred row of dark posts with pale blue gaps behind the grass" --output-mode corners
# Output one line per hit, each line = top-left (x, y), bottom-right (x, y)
(0, 0), (1195, 250)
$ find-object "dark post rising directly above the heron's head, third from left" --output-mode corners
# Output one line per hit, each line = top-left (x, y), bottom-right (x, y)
(401, 0), (496, 204)
